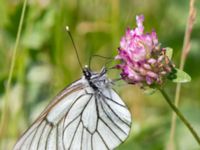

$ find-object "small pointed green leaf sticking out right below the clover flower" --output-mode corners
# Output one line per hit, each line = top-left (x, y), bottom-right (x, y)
(168, 68), (191, 83)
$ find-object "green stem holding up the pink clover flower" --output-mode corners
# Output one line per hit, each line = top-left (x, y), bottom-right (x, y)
(159, 89), (200, 145)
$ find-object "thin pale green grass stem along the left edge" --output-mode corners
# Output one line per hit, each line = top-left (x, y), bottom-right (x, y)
(0, 0), (27, 137)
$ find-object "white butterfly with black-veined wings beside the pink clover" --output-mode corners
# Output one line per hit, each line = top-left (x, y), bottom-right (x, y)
(14, 27), (131, 150)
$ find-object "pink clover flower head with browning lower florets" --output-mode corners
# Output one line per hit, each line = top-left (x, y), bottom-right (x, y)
(116, 15), (173, 86)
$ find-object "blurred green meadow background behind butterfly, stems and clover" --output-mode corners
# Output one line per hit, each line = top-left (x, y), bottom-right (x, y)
(0, 0), (200, 150)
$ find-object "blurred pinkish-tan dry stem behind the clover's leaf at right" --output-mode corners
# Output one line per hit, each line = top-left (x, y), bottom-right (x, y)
(168, 0), (196, 150)
